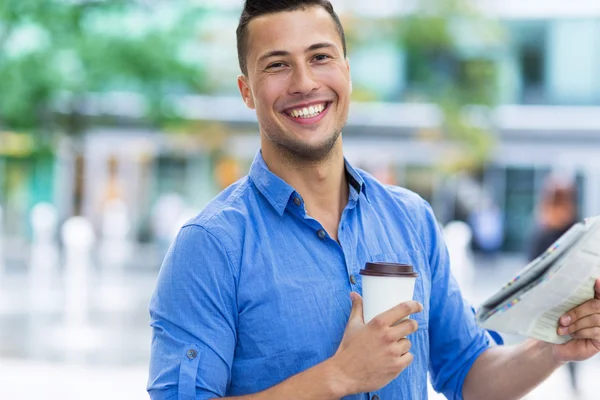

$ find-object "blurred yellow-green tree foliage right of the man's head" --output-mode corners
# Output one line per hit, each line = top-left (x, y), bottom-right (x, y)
(344, 0), (505, 173)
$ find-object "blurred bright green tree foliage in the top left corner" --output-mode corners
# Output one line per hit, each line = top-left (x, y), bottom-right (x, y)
(0, 0), (203, 135)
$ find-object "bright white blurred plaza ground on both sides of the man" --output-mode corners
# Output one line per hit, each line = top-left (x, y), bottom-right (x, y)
(0, 244), (600, 400)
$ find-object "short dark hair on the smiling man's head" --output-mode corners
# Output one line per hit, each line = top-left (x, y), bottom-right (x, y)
(236, 0), (346, 75)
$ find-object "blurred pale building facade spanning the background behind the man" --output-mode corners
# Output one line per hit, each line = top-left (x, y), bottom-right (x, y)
(0, 0), (600, 255)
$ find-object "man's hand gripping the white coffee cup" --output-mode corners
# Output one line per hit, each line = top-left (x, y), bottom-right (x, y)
(331, 293), (423, 395)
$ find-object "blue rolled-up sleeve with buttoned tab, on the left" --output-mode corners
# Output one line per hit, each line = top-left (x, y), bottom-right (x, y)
(147, 225), (238, 400)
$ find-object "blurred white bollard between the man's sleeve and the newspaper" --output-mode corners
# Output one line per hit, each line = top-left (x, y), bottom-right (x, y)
(444, 221), (475, 300)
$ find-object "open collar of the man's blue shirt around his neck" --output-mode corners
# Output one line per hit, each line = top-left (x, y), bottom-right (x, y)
(248, 150), (365, 216)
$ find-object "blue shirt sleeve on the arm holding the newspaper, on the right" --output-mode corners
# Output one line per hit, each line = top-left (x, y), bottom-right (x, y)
(427, 203), (489, 400)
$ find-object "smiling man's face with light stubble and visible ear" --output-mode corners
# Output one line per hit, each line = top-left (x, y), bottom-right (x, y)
(238, 7), (350, 161)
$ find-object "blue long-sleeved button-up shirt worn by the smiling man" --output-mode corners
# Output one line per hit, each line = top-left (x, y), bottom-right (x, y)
(148, 152), (488, 400)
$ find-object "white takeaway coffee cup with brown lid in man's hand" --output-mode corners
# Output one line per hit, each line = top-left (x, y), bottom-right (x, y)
(360, 262), (418, 323)
